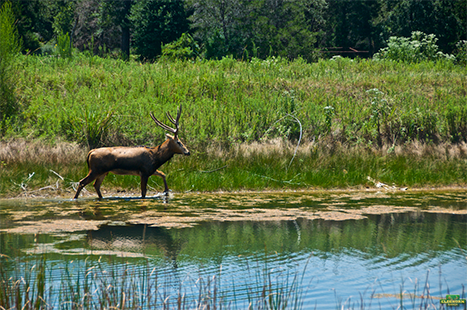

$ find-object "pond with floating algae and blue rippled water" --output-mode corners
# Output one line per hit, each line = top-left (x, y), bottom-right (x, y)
(0, 190), (467, 309)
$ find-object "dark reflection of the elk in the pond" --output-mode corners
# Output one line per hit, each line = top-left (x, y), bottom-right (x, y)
(88, 225), (182, 267)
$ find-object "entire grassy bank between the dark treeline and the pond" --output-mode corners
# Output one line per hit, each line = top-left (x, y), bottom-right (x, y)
(0, 56), (467, 195)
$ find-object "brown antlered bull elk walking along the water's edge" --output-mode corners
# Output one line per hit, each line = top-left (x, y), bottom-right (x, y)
(74, 105), (190, 199)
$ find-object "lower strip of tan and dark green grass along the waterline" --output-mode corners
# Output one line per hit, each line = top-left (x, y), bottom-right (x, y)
(0, 140), (467, 196)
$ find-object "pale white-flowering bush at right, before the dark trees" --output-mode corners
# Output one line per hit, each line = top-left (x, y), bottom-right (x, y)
(374, 31), (454, 62)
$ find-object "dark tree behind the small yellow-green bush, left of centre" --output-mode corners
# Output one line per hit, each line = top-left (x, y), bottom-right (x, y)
(130, 0), (188, 60)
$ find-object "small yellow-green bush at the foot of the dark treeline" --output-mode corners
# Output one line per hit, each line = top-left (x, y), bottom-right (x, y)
(162, 33), (201, 60)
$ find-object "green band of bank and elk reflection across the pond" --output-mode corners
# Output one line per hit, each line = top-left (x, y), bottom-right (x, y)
(84, 211), (467, 267)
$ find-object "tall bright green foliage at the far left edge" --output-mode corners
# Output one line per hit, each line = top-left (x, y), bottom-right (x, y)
(0, 2), (21, 135)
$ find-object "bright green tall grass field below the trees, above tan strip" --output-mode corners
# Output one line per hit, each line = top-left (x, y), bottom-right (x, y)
(9, 55), (467, 145)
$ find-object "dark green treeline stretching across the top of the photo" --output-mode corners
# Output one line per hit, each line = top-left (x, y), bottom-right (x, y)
(7, 0), (467, 61)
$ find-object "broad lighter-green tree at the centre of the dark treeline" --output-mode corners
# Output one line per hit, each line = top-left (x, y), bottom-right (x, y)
(189, 0), (326, 58)
